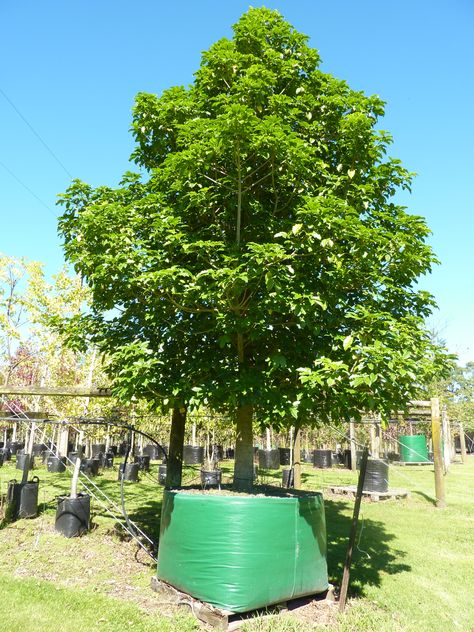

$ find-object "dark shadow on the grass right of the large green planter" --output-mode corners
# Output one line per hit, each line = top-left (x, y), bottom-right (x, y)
(324, 498), (411, 597)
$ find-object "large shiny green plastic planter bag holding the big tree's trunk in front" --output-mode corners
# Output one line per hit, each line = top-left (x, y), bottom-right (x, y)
(158, 490), (328, 612)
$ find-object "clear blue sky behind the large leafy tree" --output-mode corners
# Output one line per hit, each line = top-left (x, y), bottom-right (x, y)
(0, 0), (474, 363)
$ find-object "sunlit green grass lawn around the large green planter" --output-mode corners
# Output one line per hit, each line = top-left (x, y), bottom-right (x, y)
(0, 456), (474, 632)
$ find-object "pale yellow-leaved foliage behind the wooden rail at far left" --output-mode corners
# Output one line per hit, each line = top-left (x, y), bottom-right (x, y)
(0, 255), (117, 416)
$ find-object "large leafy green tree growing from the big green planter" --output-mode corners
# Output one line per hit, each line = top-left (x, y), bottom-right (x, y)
(60, 8), (448, 489)
